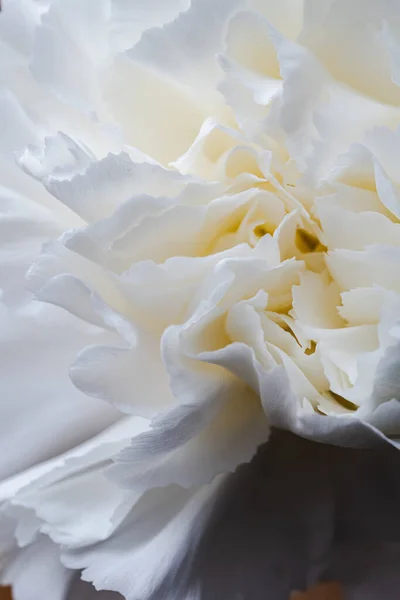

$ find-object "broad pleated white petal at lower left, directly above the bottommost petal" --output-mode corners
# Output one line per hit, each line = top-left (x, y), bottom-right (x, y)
(0, 419), (147, 547)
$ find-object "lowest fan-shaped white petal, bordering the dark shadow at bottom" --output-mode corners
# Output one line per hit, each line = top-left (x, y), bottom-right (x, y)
(63, 478), (223, 600)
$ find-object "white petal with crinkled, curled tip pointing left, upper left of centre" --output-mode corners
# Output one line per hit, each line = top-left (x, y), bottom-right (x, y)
(19, 144), (175, 222)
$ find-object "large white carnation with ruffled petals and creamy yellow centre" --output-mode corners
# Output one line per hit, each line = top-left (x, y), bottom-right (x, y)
(0, 0), (400, 600)
